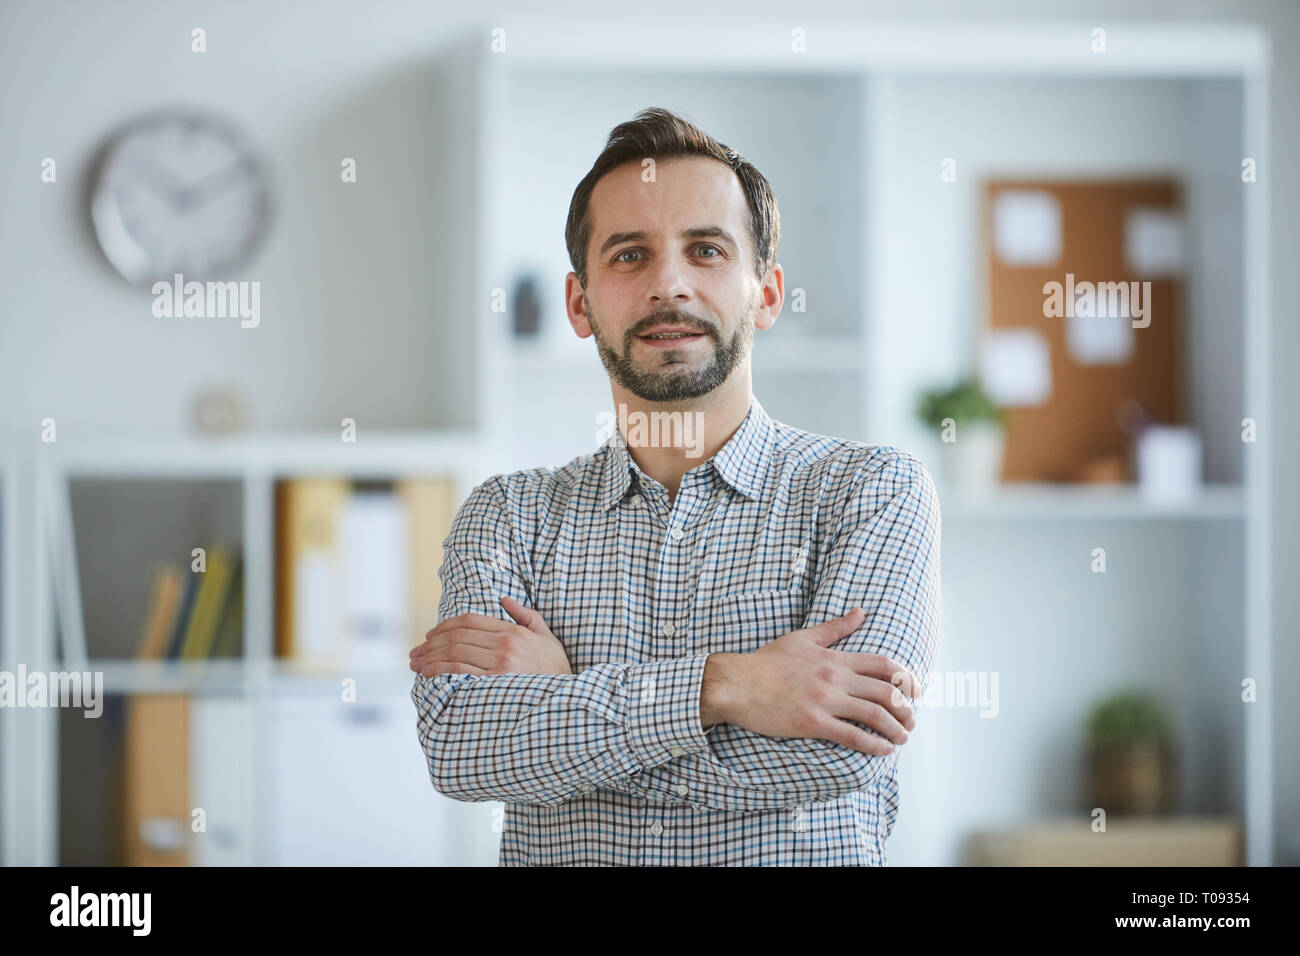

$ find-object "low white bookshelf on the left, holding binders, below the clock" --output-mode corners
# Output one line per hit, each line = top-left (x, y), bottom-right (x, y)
(0, 431), (486, 865)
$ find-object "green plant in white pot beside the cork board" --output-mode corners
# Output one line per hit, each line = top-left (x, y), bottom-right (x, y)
(917, 378), (1006, 492)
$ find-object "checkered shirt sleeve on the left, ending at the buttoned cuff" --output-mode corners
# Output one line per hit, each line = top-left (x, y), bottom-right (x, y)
(411, 477), (709, 806)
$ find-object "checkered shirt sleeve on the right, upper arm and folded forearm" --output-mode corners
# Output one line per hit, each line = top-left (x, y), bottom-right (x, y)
(616, 451), (940, 810)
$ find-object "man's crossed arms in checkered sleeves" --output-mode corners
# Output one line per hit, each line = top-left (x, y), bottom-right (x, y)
(411, 455), (940, 810)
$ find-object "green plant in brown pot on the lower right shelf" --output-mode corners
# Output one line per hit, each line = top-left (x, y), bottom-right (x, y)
(1087, 691), (1171, 814)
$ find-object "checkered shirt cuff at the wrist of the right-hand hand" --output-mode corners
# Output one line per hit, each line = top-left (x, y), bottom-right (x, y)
(623, 654), (709, 767)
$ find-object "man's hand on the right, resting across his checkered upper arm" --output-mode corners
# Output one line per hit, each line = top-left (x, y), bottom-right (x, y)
(699, 607), (920, 754)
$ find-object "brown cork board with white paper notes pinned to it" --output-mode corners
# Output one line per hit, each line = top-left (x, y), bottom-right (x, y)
(983, 179), (1186, 481)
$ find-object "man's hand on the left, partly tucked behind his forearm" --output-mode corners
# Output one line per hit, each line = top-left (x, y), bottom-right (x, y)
(411, 597), (573, 678)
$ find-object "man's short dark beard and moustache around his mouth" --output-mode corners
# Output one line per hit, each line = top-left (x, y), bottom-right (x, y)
(588, 297), (758, 402)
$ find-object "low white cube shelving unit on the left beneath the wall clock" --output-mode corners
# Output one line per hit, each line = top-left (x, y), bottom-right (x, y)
(0, 429), (486, 864)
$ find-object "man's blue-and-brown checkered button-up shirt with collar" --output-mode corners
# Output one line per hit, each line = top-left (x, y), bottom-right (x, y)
(411, 397), (940, 866)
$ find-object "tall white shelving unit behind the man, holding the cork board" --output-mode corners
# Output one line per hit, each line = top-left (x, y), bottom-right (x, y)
(465, 17), (1273, 864)
